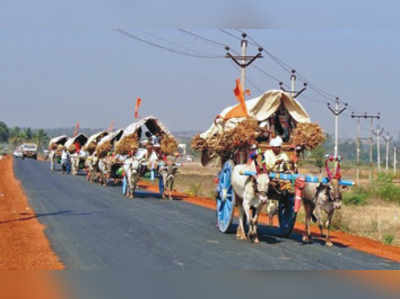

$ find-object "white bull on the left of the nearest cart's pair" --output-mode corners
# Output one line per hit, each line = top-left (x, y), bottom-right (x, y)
(231, 164), (270, 243)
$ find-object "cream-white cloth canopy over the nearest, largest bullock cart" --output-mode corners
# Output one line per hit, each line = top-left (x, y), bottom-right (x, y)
(200, 90), (311, 139)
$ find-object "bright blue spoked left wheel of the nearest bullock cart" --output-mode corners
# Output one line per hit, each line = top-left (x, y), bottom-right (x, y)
(217, 160), (235, 233)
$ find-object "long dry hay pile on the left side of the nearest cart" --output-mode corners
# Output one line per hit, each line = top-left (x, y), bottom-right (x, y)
(192, 118), (263, 156)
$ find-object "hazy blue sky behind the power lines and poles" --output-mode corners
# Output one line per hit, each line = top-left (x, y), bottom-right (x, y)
(0, 0), (400, 137)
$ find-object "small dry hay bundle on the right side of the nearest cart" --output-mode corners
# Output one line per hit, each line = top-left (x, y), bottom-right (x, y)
(291, 123), (325, 150)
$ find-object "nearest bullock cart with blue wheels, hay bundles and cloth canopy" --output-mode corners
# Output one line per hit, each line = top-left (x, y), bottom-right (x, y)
(192, 90), (324, 236)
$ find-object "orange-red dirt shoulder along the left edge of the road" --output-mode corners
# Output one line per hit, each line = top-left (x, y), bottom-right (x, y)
(0, 157), (63, 270)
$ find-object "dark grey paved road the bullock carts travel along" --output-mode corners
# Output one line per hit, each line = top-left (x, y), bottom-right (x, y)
(14, 160), (400, 270)
